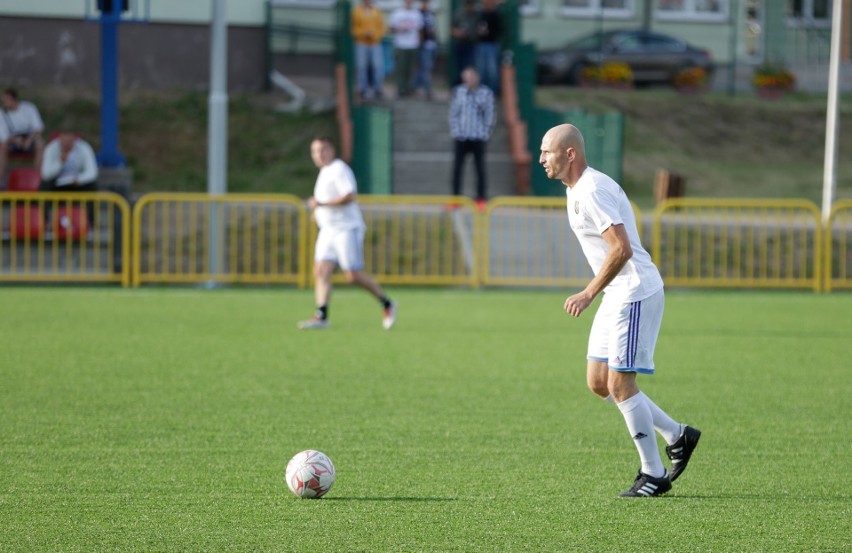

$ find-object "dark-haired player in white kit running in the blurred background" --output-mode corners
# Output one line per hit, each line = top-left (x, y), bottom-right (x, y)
(298, 136), (397, 330)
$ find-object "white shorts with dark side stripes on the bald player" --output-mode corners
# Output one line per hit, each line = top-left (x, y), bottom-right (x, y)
(588, 289), (665, 374)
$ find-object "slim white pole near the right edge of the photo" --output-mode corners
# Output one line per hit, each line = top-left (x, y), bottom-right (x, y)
(822, 0), (843, 222)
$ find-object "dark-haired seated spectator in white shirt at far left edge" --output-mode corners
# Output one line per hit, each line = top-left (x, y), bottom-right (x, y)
(0, 88), (44, 179)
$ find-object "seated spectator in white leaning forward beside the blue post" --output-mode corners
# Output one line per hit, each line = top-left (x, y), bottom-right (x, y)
(41, 131), (98, 226)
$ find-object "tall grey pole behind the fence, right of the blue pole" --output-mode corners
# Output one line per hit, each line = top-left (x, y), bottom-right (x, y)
(207, 0), (228, 276)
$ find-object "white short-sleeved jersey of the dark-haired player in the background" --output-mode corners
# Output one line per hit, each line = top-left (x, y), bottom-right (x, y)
(314, 159), (366, 230)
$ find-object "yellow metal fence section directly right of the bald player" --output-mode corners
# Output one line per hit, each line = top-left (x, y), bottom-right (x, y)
(652, 198), (822, 291)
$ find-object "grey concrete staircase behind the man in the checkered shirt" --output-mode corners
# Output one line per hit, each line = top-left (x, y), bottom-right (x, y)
(391, 98), (516, 198)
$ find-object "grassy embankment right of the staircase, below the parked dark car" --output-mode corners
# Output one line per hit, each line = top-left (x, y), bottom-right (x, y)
(538, 87), (852, 207)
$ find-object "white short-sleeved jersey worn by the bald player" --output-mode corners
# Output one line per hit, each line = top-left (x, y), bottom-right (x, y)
(566, 167), (663, 302)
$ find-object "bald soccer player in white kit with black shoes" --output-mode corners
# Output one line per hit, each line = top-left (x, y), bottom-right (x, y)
(539, 124), (701, 497)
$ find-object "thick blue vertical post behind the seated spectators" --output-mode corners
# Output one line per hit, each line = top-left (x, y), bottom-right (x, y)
(97, 0), (125, 167)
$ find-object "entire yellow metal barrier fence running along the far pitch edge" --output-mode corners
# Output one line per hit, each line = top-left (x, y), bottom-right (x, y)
(0, 193), (852, 291)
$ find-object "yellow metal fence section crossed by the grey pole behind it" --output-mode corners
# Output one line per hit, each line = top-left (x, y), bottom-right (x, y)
(133, 193), (307, 286)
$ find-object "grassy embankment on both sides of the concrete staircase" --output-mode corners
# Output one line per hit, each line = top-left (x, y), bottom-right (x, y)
(23, 87), (852, 207)
